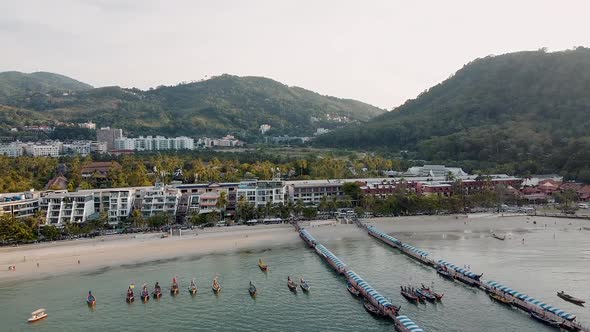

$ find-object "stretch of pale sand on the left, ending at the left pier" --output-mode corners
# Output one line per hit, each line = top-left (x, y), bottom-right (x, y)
(0, 225), (301, 282)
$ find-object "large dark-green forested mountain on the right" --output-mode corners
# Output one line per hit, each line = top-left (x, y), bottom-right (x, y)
(318, 48), (590, 181)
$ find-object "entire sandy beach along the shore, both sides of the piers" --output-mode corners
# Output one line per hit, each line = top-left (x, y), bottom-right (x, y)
(0, 214), (590, 282)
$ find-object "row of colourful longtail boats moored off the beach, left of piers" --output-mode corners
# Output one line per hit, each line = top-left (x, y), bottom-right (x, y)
(86, 259), (310, 306)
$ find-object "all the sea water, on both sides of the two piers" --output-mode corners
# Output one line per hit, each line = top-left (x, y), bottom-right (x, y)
(0, 223), (590, 331)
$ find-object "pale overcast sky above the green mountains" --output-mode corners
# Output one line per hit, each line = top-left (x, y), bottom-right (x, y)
(0, 0), (590, 109)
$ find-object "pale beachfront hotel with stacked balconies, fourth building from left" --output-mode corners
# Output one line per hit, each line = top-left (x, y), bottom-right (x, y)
(140, 184), (181, 217)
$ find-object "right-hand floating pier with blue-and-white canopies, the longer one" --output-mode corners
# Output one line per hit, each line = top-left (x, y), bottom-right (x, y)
(364, 222), (590, 332)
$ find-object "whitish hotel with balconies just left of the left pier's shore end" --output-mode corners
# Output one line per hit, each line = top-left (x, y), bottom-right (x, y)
(237, 180), (285, 207)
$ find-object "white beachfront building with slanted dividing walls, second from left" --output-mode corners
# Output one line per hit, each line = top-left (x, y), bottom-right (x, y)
(40, 192), (95, 226)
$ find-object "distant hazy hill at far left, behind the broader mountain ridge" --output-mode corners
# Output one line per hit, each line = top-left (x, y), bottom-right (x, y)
(0, 71), (92, 103)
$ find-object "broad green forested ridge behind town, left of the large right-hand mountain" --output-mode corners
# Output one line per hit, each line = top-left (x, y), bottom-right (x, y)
(0, 75), (385, 137)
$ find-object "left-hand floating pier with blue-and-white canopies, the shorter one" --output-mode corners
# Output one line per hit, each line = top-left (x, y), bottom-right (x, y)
(295, 224), (424, 332)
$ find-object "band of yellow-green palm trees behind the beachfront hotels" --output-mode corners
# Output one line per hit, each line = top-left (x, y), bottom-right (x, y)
(0, 151), (409, 192)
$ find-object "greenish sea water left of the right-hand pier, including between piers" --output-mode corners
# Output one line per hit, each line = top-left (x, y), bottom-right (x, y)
(0, 224), (585, 331)
